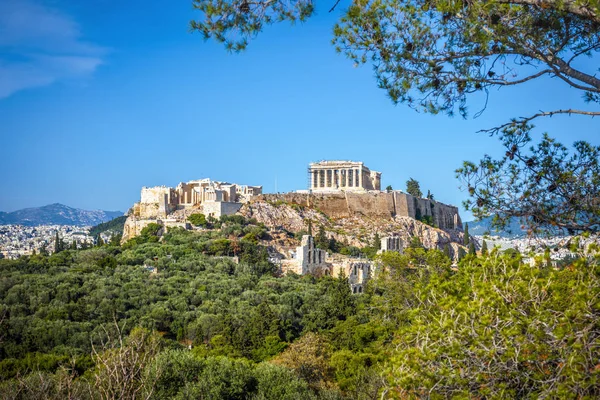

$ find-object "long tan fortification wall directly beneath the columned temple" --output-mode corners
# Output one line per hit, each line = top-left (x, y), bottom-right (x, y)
(252, 191), (462, 230)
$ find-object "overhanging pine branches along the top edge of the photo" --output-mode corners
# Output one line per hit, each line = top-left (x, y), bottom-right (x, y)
(190, 0), (600, 121)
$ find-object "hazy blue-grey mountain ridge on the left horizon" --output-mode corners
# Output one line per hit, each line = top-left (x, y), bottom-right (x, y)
(0, 203), (123, 226)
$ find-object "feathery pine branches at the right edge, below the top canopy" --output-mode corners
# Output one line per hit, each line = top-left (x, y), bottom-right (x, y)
(457, 125), (600, 234)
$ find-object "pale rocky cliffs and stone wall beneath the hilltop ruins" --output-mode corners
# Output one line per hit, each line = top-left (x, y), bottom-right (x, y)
(123, 192), (463, 255)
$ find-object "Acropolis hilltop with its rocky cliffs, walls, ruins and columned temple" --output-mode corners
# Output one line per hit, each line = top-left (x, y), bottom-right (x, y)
(123, 161), (462, 253)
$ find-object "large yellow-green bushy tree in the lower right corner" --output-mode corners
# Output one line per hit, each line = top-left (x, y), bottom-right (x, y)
(386, 256), (600, 398)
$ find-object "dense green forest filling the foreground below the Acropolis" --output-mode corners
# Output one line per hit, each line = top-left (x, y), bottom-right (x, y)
(0, 217), (600, 399)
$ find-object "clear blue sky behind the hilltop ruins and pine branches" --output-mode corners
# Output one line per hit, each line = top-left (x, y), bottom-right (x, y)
(0, 0), (600, 219)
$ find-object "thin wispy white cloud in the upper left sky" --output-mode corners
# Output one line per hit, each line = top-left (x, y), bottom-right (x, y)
(0, 0), (106, 99)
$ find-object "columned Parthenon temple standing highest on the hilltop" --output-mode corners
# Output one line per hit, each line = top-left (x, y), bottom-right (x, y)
(309, 161), (381, 192)
